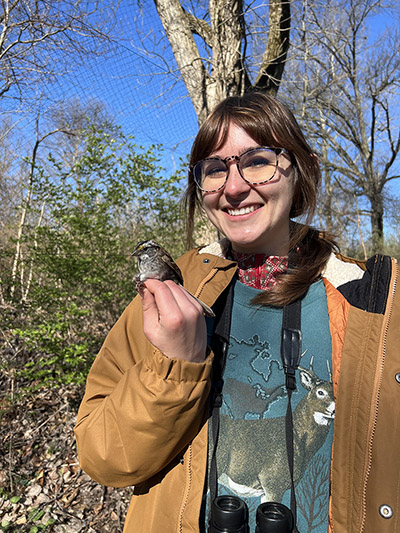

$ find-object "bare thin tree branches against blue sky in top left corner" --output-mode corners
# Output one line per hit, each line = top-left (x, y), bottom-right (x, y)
(0, 0), (115, 99)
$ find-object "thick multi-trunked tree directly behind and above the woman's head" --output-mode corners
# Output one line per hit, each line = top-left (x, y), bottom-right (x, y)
(150, 0), (290, 123)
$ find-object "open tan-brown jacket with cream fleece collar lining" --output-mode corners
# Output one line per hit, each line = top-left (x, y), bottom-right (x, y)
(75, 243), (400, 533)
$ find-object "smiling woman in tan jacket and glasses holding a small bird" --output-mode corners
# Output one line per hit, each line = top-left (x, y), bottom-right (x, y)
(75, 93), (400, 533)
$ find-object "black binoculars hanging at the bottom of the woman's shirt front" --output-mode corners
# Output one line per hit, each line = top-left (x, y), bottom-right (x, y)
(208, 496), (294, 533)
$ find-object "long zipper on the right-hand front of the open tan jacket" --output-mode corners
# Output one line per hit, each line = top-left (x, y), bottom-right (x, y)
(360, 260), (397, 533)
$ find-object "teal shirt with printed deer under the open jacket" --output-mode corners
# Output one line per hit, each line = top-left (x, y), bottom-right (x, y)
(208, 281), (334, 533)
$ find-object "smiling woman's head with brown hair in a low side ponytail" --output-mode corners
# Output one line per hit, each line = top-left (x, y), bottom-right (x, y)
(186, 93), (334, 306)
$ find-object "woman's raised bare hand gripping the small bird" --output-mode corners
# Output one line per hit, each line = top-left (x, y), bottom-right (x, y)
(141, 279), (207, 363)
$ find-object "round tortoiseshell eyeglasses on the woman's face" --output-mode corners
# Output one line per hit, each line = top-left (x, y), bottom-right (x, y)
(191, 147), (288, 192)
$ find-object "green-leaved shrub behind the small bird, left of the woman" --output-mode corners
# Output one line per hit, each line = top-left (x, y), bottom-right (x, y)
(0, 113), (184, 384)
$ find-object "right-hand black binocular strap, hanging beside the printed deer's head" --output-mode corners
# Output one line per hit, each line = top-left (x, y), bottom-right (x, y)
(281, 299), (301, 533)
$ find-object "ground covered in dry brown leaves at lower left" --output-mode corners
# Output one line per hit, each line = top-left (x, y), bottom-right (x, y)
(0, 375), (132, 533)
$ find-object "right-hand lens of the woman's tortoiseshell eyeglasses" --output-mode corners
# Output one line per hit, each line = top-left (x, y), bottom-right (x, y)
(239, 148), (278, 183)
